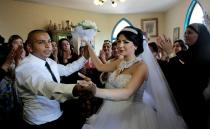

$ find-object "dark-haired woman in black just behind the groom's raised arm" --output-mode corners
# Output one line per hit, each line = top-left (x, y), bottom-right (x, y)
(58, 38), (87, 124)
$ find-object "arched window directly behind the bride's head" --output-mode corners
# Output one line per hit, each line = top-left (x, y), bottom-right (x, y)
(111, 18), (132, 41)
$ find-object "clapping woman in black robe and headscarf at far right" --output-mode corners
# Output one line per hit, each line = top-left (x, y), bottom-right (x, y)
(158, 23), (210, 129)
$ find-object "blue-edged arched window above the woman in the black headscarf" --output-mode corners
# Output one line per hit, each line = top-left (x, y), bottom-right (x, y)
(184, 0), (204, 29)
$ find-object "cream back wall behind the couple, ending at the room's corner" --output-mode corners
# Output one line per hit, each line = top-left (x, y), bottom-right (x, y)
(0, 0), (165, 53)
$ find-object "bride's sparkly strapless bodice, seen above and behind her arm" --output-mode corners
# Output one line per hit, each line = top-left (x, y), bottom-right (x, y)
(105, 71), (145, 101)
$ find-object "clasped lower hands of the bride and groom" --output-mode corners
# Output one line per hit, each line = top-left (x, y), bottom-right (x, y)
(73, 73), (96, 97)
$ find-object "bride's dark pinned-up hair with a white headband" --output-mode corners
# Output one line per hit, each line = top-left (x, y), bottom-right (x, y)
(117, 26), (144, 56)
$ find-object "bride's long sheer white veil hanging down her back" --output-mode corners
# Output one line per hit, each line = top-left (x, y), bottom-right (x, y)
(138, 39), (187, 129)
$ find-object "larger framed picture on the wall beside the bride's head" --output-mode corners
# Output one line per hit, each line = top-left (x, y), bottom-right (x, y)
(141, 18), (158, 37)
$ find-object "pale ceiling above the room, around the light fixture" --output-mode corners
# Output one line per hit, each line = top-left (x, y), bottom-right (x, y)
(17, 0), (181, 14)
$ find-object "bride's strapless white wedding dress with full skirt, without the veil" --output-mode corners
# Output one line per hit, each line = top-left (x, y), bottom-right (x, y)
(82, 67), (158, 129)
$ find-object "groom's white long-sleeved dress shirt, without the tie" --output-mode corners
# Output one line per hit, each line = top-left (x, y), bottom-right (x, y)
(16, 54), (86, 125)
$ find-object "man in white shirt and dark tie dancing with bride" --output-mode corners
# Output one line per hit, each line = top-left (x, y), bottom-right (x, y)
(15, 30), (92, 129)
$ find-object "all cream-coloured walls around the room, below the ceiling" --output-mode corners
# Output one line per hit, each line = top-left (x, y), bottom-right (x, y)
(0, 0), (210, 53)
